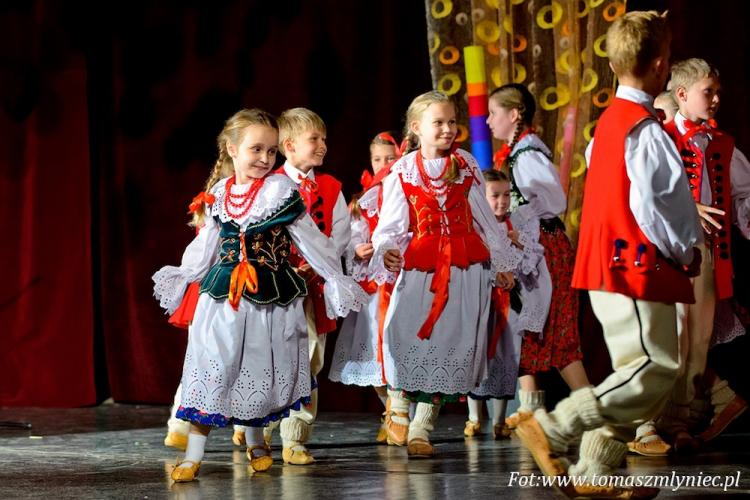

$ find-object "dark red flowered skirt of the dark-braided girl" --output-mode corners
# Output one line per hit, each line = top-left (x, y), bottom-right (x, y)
(519, 224), (583, 375)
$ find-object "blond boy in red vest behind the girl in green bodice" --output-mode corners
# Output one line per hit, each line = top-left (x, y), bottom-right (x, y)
(254, 108), (351, 465)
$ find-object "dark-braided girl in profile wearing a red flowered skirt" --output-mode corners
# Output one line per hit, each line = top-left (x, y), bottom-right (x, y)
(487, 84), (590, 428)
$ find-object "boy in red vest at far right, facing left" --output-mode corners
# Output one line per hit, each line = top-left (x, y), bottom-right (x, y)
(658, 58), (750, 451)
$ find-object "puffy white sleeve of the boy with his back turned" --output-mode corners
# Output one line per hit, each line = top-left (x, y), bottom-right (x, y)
(625, 120), (703, 265)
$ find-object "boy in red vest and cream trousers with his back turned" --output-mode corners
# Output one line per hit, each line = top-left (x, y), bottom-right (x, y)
(516, 11), (702, 498)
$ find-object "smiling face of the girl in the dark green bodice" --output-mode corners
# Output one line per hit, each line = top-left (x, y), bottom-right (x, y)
(227, 125), (279, 184)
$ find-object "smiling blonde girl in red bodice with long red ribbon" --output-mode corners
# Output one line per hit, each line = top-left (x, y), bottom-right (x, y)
(370, 91), (521, 456)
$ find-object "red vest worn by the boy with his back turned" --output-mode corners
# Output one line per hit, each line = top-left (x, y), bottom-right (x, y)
(572, 98), (695, 304)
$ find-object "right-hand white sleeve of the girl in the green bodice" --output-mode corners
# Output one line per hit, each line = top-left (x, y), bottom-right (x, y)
(287, 213), (369, 318)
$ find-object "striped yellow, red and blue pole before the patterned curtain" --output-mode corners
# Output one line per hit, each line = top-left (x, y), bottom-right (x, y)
(464, 45), (492, 170)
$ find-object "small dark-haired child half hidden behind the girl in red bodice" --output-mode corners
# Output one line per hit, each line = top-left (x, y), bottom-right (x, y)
(464, 170), (552, 439)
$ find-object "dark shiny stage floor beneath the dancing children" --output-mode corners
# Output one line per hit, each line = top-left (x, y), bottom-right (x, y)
(0, 404), (750, 500)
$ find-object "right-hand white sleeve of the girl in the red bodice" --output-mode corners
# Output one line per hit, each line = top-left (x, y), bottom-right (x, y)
(469, 161), (523, 273)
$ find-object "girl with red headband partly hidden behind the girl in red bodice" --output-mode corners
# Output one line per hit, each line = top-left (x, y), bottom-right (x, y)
(328, 132), (401, 443)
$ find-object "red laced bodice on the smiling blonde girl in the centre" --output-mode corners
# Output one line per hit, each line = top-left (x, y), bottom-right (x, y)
(399, 169), (490, 272)
